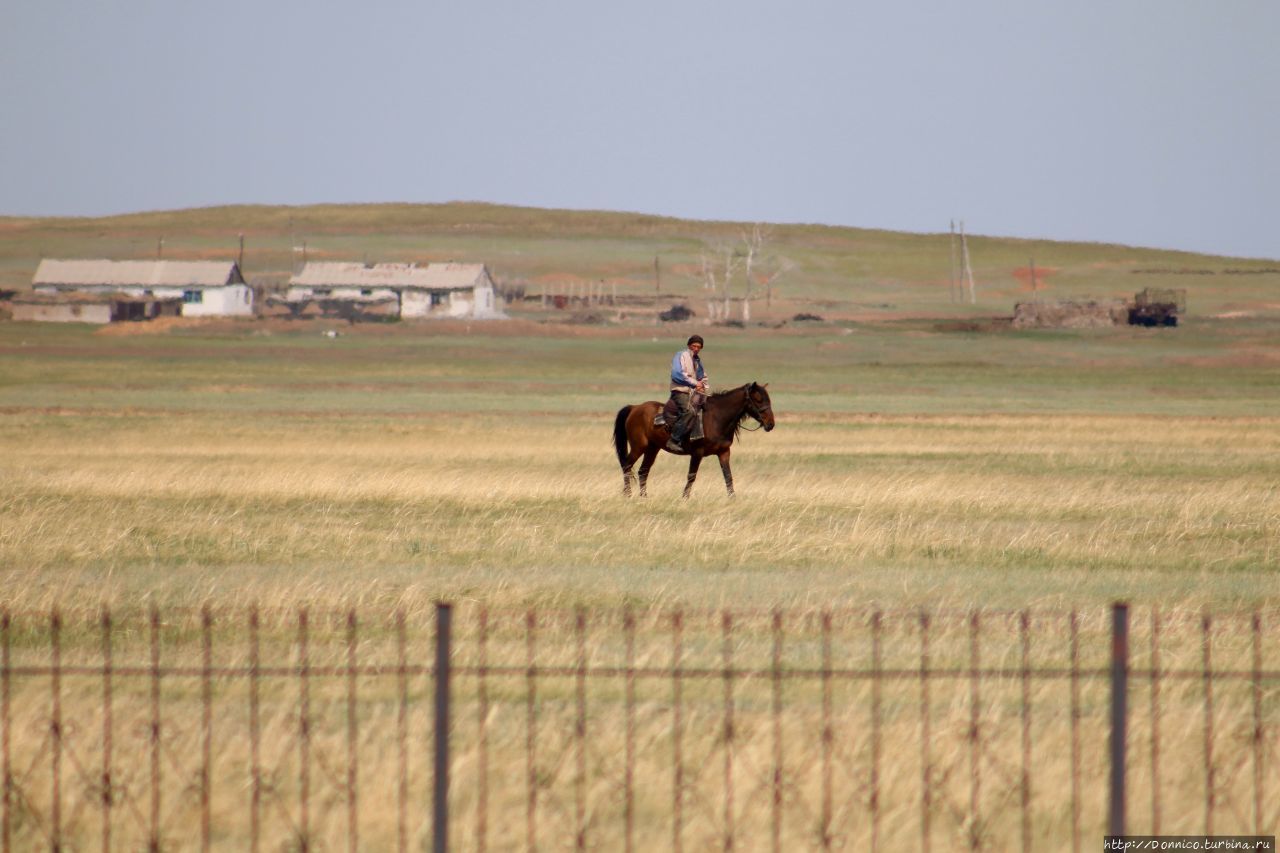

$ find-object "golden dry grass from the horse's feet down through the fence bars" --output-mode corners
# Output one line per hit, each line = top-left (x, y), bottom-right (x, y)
(0, 414), (1280, 849)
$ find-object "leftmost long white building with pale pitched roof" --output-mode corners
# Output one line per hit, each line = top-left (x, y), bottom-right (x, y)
(31, 259), (253, 316)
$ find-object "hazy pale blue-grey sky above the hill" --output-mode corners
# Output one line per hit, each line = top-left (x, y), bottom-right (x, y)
(0, 0), (1280, 259)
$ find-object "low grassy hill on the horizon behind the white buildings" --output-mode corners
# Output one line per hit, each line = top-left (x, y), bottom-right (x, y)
(0, 202), (1280, 319)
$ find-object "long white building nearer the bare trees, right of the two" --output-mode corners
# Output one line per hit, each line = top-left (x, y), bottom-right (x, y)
(284, 263), (504, 319)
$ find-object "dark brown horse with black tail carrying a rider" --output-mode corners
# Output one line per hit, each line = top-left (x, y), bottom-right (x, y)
(613, 382), (773, 498)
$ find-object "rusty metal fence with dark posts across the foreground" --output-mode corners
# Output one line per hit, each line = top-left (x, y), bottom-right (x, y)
(0, 605), (1280, 853)
